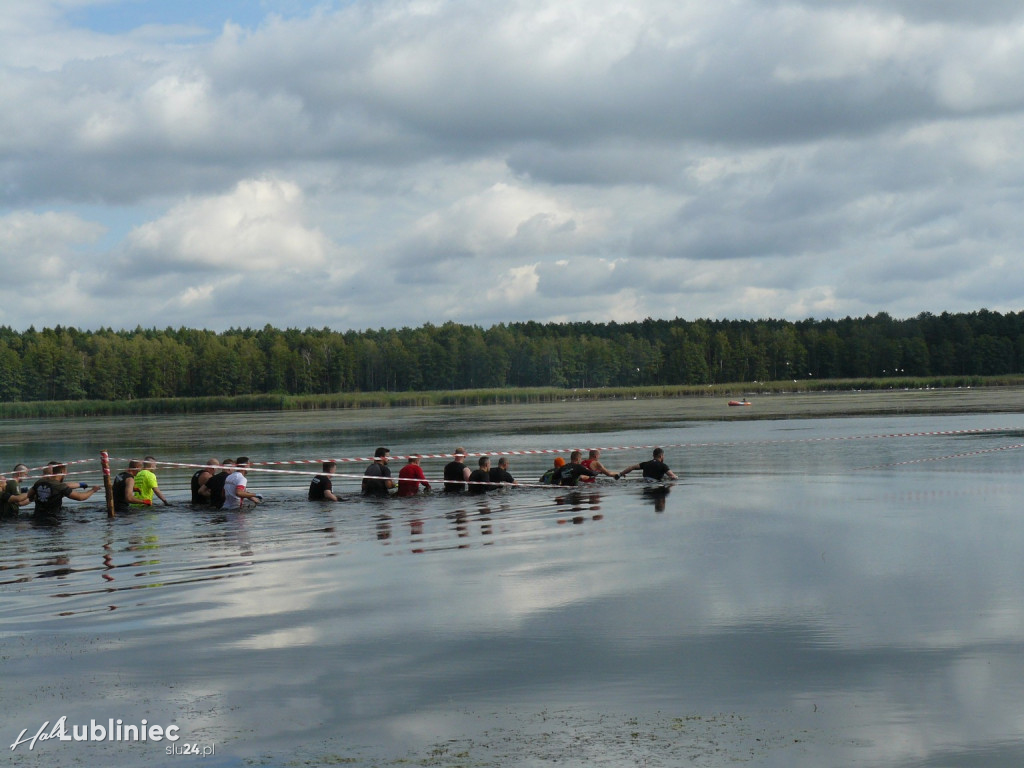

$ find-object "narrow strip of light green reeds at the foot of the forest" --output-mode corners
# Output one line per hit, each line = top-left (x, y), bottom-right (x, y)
(0, 376), (1024, 419)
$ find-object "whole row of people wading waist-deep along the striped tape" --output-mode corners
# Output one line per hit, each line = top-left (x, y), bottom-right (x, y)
(0, 446), (677, 519)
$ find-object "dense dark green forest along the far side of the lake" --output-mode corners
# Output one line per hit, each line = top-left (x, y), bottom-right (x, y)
(0, 309), (1024, 401)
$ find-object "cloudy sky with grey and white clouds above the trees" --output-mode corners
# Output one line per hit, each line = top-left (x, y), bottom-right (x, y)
(0, 0), (1024, 331)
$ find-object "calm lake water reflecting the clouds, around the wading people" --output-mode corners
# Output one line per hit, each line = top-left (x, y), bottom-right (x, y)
(0, 402), (1024, 768)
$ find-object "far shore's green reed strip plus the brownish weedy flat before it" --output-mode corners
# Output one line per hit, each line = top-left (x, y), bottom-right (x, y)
(0, 377), (1024, 421)
